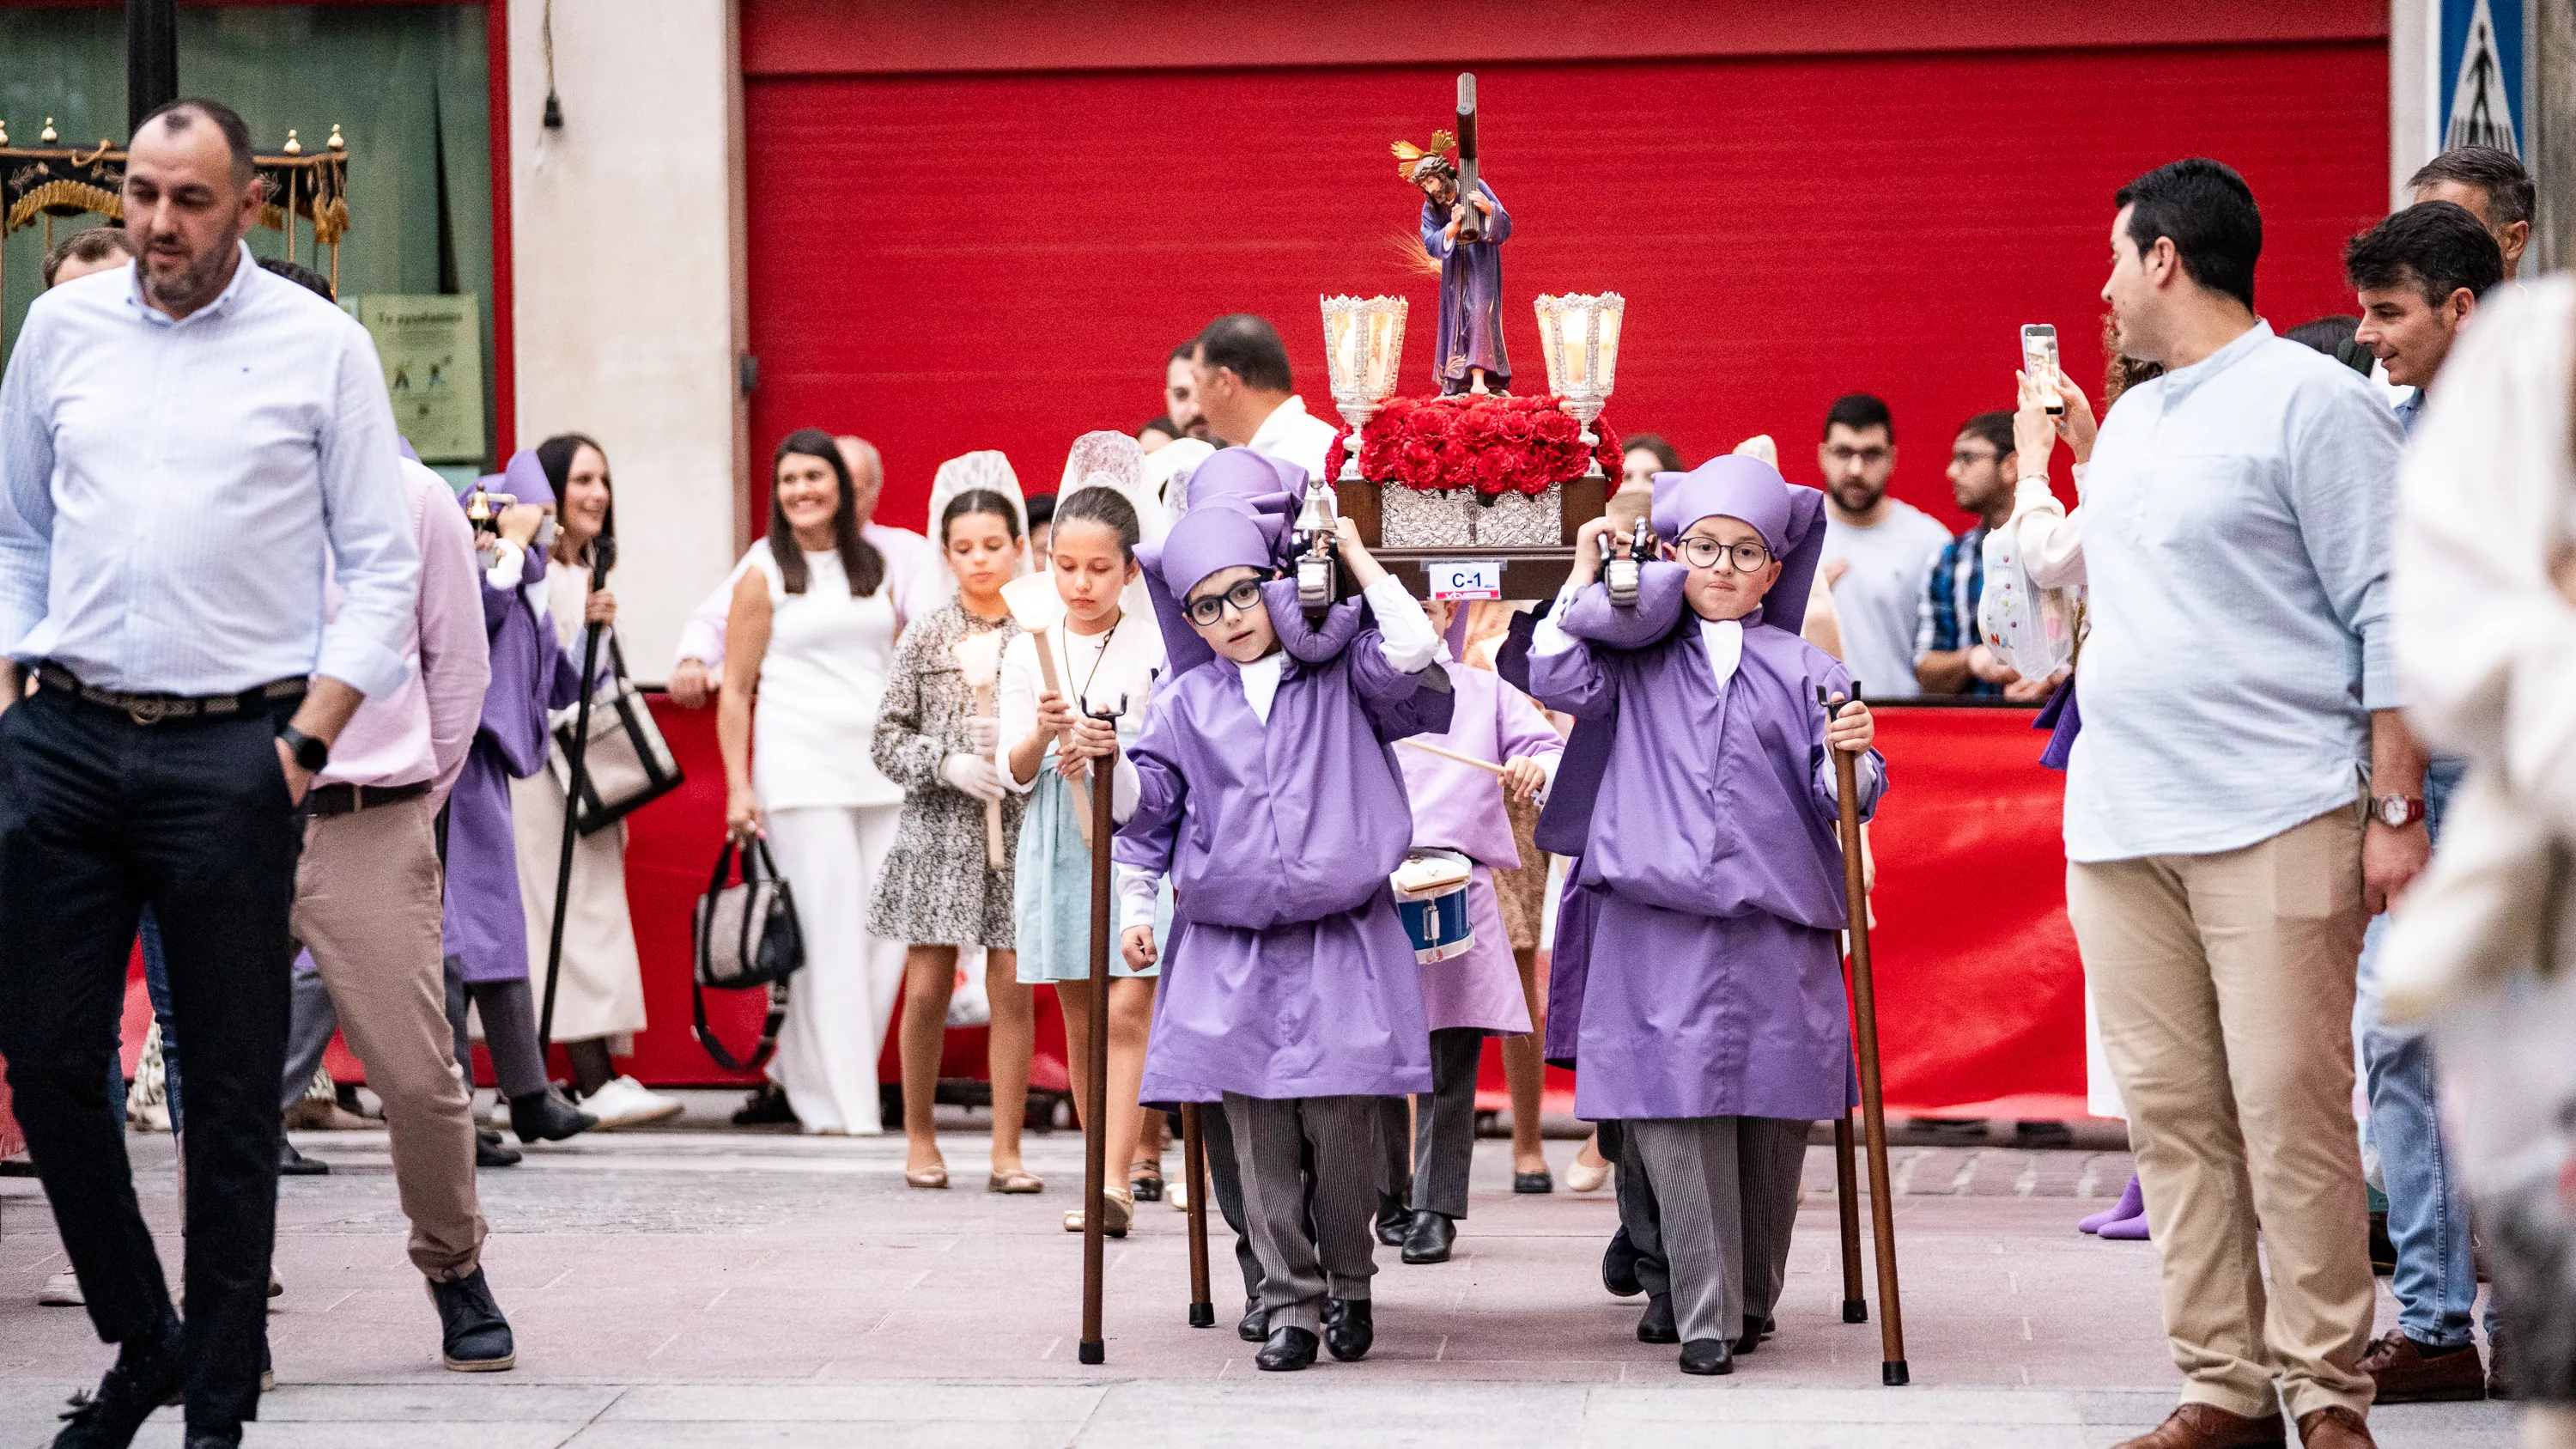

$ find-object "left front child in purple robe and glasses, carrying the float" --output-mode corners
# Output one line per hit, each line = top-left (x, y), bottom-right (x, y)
(1097, 500), (1450, 1372)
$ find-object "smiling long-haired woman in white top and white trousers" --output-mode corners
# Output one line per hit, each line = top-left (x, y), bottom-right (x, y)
(716, 428), (904, 1137)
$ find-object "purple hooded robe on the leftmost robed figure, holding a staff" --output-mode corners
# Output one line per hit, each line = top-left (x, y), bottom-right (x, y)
(443, 451), (582, 983)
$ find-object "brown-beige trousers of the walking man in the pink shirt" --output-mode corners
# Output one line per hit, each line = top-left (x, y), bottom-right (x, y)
(294, 797), (484, 1282)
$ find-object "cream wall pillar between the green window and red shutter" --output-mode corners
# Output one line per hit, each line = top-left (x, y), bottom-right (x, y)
(510, 0), (744, 680)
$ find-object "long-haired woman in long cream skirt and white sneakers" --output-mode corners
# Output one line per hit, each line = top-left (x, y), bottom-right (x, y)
(510, 433), (680, 1129)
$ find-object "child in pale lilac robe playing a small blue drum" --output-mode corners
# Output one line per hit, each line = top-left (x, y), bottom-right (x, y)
(1378, 593), (1566, 1263)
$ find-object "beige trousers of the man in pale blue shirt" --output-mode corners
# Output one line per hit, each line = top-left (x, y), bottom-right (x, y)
(2066, 807), (2372, 1418)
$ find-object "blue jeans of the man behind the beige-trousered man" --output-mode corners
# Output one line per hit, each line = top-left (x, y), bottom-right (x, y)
(2354, 761), (2494, 1349)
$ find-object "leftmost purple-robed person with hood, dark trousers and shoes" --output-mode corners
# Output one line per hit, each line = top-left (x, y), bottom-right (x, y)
(443, 448), (616, 1142)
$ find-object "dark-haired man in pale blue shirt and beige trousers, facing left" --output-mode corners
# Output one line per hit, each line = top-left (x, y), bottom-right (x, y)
(2071, 160), (2432, 1449)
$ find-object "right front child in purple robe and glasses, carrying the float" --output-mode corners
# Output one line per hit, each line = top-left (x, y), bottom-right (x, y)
(1530, 456), (1886, 1374)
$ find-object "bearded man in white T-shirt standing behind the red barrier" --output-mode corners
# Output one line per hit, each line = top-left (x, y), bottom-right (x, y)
(1816, 392), (1950, 698)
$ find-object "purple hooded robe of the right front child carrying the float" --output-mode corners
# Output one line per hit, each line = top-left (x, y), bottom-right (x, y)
(1530, 456), (1886, 1122)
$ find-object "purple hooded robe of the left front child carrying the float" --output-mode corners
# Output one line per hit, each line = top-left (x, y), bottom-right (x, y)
(1110, 505), (1450, 1101)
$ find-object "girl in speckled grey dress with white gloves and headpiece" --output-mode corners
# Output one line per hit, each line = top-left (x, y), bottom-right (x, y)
(868, 469), (1046, 1194)
